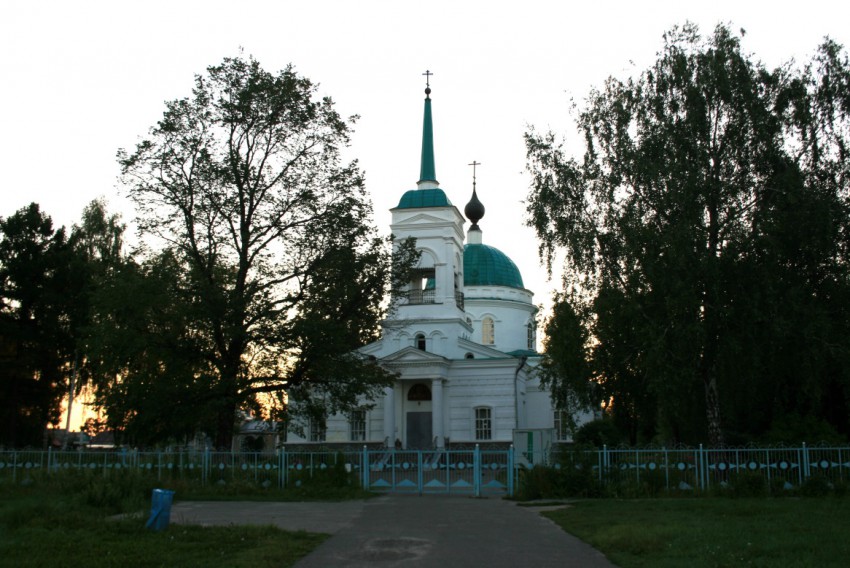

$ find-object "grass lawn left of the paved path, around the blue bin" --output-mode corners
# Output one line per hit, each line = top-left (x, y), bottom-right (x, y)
(0, 481), (334, 568)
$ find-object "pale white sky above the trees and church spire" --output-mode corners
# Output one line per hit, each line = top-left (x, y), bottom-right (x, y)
(0, 0), (850, 342)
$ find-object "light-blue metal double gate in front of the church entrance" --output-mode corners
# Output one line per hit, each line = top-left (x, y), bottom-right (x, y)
(361, 446), (514, 497)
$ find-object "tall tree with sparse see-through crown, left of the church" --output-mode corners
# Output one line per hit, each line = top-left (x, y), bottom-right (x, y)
(113, 58), (414, 446)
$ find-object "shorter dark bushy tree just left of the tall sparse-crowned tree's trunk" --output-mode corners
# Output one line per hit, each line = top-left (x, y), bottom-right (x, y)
(87, 251), (219, 446)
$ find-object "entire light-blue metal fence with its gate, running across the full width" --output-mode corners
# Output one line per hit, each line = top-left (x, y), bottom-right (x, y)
(0, 444), (850, 496)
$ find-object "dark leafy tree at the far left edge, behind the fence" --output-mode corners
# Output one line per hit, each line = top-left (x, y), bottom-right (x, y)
(0, 203), (74, 447)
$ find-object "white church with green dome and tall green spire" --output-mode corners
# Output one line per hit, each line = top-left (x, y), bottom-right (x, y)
(287, 81), (584, 449)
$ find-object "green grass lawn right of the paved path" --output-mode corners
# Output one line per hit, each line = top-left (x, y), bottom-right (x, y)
(544, 497), (850, 568)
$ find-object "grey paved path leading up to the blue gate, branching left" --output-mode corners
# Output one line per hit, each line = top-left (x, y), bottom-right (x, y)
(171, 495), (614, 568)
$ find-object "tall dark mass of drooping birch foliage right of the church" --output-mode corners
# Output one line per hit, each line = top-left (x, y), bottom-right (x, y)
(526, 25), (850, 444)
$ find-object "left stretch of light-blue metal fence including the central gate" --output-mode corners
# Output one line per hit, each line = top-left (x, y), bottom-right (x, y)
(0, 446), (514, 496)
